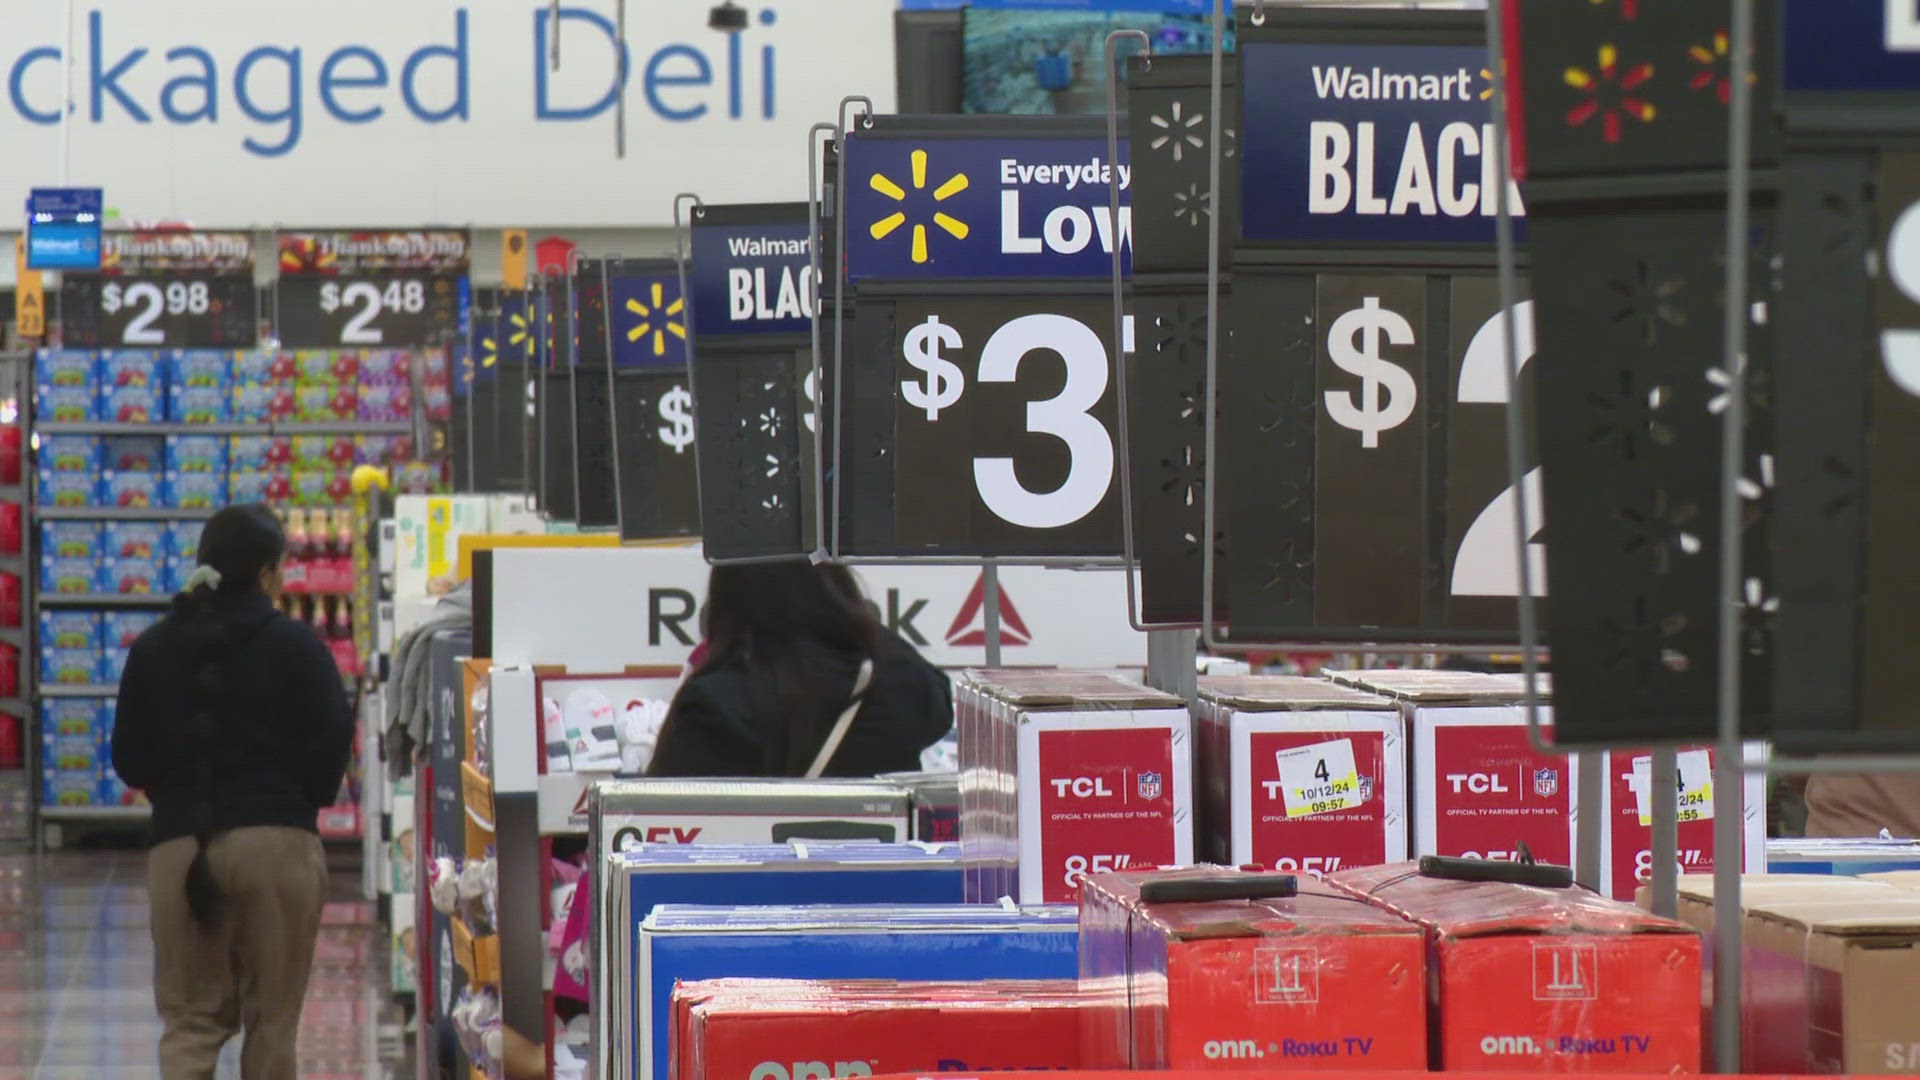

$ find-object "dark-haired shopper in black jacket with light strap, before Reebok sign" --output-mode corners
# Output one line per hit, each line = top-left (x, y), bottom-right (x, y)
(647, 563), (954, 776)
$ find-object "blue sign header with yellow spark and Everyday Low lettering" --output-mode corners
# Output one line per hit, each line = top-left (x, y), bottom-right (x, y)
(841, 135), (1133, 281)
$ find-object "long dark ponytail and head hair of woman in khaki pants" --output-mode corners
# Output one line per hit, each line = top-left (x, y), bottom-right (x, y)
(173, 503), (286, 926)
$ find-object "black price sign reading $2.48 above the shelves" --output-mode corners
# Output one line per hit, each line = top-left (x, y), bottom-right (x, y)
(278, 273), (461, 348)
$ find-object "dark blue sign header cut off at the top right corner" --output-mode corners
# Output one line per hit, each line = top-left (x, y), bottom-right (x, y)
(1780, 0), (1920, 92)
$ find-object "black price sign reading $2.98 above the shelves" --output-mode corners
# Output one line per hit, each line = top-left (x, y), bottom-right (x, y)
(60, 273), (257, 348)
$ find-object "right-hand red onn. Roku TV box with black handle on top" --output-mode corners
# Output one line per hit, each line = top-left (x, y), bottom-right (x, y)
(1327, 865), (1701, 1074)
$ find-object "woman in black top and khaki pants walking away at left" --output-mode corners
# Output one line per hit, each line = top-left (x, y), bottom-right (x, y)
(113, 505), (353, 1080)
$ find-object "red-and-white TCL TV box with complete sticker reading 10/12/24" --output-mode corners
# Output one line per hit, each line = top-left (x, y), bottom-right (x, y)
(1194, 675), (1407, 876)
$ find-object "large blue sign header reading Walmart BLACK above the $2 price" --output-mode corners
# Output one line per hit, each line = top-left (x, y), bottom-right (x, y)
(1240, 42), (1521, 244)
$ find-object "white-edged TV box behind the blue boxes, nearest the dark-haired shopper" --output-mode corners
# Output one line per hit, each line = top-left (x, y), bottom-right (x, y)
(588, 778), (910, 1061)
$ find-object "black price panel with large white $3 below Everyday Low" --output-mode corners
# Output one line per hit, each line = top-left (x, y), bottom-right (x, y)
(895, 296), (1119, 555)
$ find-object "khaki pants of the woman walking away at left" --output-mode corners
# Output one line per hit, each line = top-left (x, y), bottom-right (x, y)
(148, 826), (326, 1080)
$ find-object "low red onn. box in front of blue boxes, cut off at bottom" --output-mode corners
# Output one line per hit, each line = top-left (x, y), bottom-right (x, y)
(672, 980), (1085, 1080)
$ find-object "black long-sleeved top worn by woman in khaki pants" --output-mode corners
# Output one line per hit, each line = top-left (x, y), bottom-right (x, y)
(113, 592), (353, 844)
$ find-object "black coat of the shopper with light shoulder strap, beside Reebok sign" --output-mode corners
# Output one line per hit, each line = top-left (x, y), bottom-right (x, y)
(647, 632), (954, 776)
